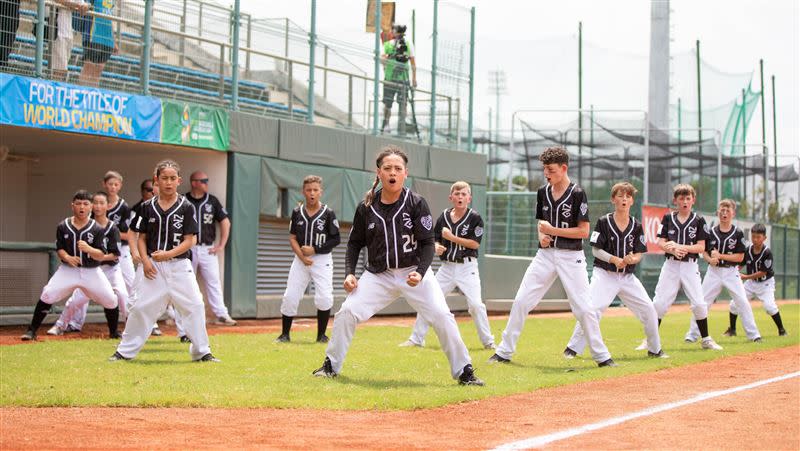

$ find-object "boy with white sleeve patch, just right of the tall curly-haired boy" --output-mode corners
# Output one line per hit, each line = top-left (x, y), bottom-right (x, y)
(564, 182), (668, 359)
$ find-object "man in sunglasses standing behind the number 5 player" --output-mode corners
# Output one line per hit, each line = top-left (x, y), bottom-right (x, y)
(184, 171), (236, 326)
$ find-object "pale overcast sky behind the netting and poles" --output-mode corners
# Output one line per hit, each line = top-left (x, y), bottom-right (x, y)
(236, 0), (800, 167)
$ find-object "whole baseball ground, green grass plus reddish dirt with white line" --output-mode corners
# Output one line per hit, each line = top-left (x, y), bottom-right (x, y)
(0, 302), (800, 449)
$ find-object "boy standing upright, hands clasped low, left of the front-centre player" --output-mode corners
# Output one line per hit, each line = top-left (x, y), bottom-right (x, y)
(275, 175), (341, 343)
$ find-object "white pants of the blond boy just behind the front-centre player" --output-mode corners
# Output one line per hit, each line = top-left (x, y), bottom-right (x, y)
(408, 257), (494, 346)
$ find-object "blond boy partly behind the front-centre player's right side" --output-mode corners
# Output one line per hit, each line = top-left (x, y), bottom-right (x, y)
(400, 182), (494, 349)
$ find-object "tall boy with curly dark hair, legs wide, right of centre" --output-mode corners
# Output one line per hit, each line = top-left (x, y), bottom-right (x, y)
(489, 146), (617, 367)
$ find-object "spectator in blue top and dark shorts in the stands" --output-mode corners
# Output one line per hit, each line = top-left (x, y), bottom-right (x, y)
(79, 0), (117, 86)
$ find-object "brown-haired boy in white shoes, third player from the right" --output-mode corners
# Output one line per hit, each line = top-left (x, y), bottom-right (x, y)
(636, 183), (722, 351)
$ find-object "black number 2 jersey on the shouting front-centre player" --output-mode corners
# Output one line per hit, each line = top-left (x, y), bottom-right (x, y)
(345, 188), (434, 276)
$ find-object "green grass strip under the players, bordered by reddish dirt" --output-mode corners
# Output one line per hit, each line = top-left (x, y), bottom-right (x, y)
(0, 304), (800, 410)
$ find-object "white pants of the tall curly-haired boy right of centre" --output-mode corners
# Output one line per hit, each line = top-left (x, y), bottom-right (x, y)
(495, 248), (611, 363)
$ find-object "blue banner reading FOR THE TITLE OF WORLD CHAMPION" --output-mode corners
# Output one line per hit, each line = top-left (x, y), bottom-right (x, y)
(0, 73), (161, 142)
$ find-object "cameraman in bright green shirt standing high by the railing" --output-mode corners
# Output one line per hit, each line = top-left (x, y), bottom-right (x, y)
(381, 25), (417, 136)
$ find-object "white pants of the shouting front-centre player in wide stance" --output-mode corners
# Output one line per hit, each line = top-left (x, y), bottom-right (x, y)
(325, 267), (471, 379)
